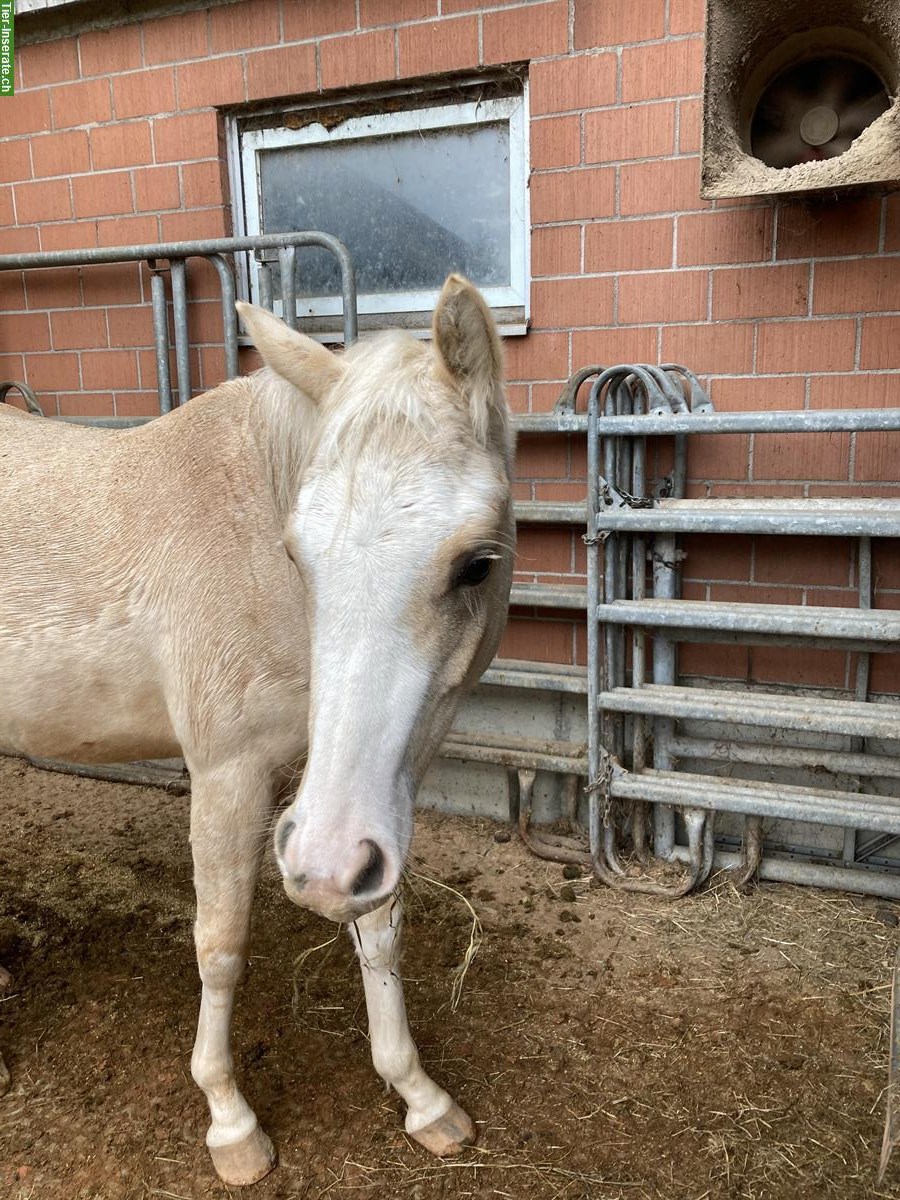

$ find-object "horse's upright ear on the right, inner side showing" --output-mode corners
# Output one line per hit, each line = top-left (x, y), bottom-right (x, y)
(432, 275), (508, 443)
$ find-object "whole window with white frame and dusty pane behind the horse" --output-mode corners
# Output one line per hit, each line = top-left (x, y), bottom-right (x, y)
(232, 85), (528, 336)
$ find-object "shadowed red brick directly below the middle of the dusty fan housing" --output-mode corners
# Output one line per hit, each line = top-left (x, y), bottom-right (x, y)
(776, 199), (881, 258)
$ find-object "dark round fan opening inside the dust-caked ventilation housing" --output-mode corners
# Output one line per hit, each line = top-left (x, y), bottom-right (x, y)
(750, 54), (890, 167)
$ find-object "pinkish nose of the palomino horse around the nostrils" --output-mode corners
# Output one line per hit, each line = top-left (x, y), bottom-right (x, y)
(278, 821), (397, 920)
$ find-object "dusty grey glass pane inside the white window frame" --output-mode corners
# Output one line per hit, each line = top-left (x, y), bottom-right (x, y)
(259, 121), (510, 296)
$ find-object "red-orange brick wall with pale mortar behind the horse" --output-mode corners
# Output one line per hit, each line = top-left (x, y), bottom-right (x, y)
(0, 0), (900, 691)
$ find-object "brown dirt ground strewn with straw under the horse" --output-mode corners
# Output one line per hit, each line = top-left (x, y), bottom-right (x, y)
(0, 758), (900, 1200)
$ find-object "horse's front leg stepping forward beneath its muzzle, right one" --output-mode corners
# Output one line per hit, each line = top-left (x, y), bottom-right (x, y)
(350, 898), (475, 1157)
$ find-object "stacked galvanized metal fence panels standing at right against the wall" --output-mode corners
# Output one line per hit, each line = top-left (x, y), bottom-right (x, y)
(573, 367), (900, 898)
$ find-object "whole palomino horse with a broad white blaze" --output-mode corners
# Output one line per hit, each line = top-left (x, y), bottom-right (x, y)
(0, 276), (514, 1184)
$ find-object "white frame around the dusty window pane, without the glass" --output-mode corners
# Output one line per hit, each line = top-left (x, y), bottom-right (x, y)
(235, 91), (530, 332)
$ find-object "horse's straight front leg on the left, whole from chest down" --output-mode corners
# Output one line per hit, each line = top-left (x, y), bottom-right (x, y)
(191, 767), (276, 1187)
